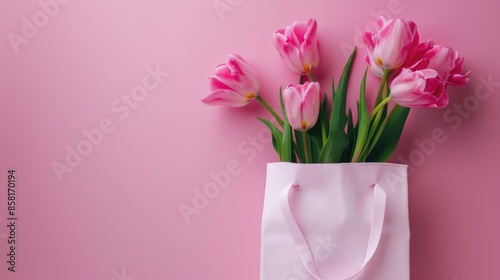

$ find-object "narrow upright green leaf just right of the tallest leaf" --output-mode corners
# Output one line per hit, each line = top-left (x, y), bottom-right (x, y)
(352, 68), (370, 162)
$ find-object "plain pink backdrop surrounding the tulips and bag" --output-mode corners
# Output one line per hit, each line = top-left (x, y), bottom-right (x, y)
(0, 0), (500, 280)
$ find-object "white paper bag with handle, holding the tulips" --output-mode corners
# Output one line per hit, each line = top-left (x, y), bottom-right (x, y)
(260, 163), (410, 280)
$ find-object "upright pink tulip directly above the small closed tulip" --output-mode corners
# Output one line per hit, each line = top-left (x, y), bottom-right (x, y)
(274, 19), (319, 75)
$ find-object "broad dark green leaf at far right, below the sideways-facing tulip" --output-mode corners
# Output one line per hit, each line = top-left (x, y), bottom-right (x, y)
(366, 105), (410, 162)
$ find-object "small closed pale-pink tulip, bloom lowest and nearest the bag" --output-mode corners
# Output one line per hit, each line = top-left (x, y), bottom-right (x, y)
(283, 82), (321, 131)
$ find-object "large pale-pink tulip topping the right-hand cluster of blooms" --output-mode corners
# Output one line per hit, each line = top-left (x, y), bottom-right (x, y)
(363, 17), (419, 77)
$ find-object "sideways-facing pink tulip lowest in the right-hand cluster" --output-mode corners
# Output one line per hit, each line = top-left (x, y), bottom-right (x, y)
(390, 68), (448, 108)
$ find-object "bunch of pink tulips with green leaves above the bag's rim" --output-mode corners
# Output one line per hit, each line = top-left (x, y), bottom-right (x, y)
(202, 17), (470, 163)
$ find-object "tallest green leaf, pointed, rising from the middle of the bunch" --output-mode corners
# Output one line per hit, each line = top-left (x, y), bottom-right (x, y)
(319, 48), (356, 163)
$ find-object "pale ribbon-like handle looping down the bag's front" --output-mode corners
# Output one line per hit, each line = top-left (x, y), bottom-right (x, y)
(280, 183), (387, 280)
